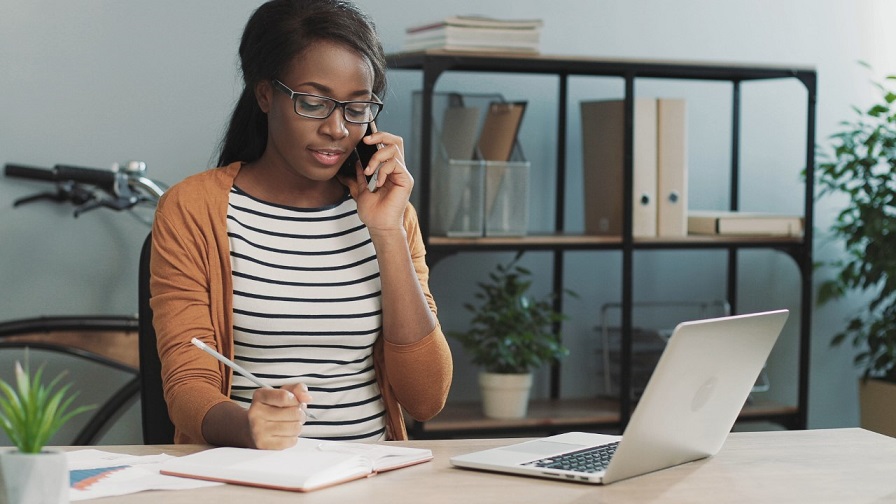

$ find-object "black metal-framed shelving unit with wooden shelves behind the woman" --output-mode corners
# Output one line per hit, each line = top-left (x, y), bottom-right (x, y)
(387, 50), (817, 438)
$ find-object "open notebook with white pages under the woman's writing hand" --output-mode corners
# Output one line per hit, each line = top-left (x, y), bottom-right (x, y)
(160, 438), (432, 492)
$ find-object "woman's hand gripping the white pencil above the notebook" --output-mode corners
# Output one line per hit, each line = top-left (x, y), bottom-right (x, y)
(249, 383), (311, 450)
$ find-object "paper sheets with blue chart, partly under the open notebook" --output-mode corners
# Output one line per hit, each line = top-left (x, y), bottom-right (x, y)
(66, 449), (221, 502)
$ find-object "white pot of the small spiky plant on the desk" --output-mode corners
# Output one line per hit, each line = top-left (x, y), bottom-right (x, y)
(0, 450), (69, 504)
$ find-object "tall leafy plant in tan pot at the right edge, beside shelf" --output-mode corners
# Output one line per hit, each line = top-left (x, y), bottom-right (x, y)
(816, 68), (896, 435)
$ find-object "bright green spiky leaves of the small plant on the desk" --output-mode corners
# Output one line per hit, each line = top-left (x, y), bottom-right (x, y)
(0, 358), (94, 453)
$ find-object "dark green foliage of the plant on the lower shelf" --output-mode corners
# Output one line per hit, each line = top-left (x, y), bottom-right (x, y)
(449, 252), (574, 373)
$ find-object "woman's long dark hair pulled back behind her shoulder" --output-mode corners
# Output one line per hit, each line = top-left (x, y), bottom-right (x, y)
(218, 0), (386, 166)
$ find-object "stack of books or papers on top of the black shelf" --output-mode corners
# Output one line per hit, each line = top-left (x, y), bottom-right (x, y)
(404, 16), (543, 53)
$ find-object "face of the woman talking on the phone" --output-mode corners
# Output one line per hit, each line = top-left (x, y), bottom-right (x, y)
(258, 41), (373, 181)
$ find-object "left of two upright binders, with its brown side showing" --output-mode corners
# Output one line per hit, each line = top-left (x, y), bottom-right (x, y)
(580, 98), (657, 237)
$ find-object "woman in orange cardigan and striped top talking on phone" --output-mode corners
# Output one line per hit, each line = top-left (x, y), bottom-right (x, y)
(151, 0), (452, 449)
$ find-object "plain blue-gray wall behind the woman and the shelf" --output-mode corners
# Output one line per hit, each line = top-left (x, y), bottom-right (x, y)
(0, 0), (896, 442)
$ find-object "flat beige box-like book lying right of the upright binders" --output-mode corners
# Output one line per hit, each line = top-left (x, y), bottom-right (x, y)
(688, 210), (803, 237)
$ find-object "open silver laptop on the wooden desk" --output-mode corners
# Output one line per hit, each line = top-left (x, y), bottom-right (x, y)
(450, 310), (789, 484)
